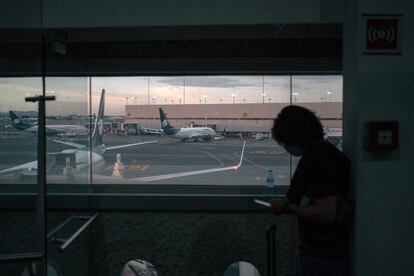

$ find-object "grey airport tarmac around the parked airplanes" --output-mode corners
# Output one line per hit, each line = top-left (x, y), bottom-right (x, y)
(0, 133), (290, 186)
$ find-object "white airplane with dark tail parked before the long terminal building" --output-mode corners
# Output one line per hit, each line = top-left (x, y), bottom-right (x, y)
(160, 108), (215, 142)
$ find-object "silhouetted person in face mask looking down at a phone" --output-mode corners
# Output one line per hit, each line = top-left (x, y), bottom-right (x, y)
(270, 105), (351, 276)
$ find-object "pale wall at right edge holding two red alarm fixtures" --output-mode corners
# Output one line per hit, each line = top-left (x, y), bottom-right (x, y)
(344, 0), (414, 276)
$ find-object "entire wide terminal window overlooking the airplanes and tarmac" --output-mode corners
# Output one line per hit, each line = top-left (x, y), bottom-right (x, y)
(0, 75), (342, 192)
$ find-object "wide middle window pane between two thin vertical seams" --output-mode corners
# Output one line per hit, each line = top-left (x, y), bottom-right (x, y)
(92, 76), (290, 186)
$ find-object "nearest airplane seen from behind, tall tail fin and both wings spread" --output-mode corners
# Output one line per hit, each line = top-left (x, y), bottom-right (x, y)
(0, 89), (246, 183)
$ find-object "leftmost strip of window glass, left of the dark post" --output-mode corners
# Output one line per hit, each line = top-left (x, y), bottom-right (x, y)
(0, 78), (42, 184)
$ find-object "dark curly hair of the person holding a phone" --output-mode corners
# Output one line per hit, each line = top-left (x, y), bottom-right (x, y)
(272, 105), (323, 147)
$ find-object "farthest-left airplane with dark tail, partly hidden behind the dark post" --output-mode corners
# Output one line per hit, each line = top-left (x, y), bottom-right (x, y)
(9, 111), (88, 136)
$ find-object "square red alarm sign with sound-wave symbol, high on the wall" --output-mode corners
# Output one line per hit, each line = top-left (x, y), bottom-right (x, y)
(363, 15), (401, 54)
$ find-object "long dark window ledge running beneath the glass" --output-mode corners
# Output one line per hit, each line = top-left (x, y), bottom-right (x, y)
(0, 185), (288, 212)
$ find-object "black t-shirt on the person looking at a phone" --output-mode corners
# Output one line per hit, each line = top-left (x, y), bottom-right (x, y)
(287, 141), (351, 259)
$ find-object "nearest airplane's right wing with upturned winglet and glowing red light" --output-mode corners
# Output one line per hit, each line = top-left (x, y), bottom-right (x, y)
(93, 141), (246, 184)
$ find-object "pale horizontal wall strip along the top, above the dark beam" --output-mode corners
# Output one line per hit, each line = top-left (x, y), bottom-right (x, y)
(0, 0), (343, 28)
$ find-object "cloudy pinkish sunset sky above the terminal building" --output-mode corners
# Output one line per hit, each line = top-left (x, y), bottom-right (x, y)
(0, 75), (342, 115)
